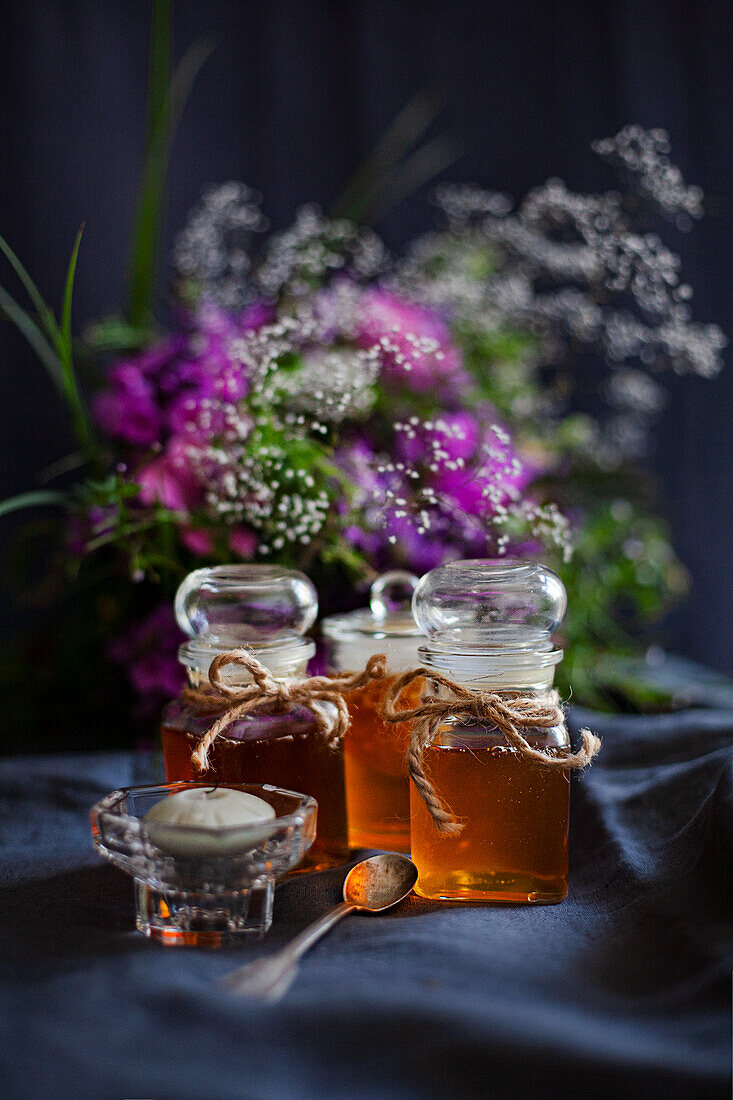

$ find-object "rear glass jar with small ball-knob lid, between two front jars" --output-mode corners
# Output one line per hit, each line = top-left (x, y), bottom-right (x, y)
(321, 570), (419, 853)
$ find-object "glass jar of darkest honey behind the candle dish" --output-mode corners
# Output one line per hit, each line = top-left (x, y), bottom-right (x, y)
(161, 565), (348, 870)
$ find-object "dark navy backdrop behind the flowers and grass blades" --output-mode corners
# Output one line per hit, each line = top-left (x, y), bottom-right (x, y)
(0, 0), (733, 669)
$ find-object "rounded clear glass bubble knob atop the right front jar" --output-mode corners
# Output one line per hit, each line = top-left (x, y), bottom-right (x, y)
(413, 558), (567, 655)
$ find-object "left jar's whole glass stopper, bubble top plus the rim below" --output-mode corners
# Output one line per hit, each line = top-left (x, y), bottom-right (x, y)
(175, 564), (318, 671)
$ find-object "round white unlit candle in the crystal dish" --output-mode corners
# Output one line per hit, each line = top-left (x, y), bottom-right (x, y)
(143, 787), (275, 857)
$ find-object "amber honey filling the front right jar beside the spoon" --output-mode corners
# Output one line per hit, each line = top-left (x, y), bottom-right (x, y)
(411, 738), (570, 903)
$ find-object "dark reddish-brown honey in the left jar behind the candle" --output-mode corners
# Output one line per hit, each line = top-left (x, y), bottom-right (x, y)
(161, 725), (348, 870)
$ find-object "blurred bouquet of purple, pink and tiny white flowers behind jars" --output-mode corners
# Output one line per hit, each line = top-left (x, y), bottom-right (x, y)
(0, 111), (725, 743)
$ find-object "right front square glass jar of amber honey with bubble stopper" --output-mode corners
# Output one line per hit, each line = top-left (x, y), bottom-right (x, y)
(407, 559), (570, 904)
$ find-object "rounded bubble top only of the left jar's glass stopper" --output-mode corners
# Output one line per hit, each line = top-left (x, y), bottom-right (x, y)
(175, 565), (318, 646)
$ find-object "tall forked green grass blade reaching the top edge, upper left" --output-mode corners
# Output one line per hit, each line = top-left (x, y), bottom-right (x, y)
(127, 0), (214, 328)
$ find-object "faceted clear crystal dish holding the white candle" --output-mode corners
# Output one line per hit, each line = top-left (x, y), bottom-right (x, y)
(90, 783), (317, 947)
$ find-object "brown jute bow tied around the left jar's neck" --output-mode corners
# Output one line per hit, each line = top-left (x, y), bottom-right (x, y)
(183, 649), (386, 771)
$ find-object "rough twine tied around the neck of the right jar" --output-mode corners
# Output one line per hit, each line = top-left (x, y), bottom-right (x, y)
(382, 668), (601, 836)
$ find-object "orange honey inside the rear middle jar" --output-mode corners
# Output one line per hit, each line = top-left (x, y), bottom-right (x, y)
(343, 678), (419, 853)
